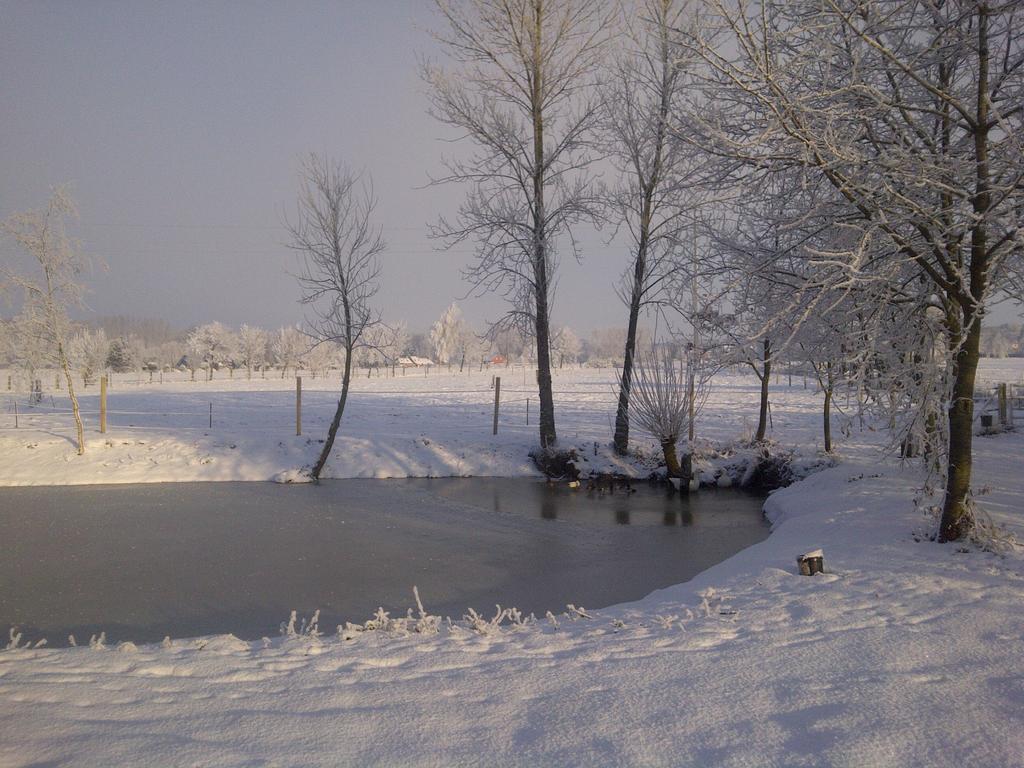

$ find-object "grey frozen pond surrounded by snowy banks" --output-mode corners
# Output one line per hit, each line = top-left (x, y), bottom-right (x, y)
(0, 478), (768, 645)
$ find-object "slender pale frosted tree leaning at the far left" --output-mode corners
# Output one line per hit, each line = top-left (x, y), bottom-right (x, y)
(2, 186), (85, 456)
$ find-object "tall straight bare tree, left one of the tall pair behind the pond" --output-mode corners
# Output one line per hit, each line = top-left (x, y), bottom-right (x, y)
(424, 0), (611, 447)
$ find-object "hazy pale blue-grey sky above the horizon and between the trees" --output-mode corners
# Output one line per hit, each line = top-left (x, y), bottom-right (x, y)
(0, 0), (625, 330)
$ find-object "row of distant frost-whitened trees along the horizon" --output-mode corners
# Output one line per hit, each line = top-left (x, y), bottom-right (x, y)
(0, 303), (667, 386)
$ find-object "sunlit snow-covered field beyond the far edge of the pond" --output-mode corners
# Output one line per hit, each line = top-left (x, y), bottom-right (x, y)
(0, 367), (864, 485)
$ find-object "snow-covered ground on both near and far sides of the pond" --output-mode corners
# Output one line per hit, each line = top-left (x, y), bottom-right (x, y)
(0, 371), (1024, 766)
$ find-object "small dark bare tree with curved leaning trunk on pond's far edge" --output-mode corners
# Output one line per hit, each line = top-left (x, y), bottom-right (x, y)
(286, 155), (386, 481)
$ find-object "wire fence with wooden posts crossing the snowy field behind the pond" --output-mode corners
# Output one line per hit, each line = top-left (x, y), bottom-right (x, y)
(0, 369), (1024, 435)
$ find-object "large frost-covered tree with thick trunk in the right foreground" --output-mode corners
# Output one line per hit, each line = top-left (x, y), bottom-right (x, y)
(691, 0), (1024, 542)
